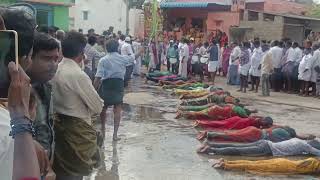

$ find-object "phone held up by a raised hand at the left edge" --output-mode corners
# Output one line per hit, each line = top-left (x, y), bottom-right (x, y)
(0, 31), (18, 95)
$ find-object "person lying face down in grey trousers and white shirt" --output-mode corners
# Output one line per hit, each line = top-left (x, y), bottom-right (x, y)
(197, 138), (320, 156)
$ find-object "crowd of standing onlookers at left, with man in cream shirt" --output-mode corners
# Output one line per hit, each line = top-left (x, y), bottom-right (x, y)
(0, 3), (144, 180)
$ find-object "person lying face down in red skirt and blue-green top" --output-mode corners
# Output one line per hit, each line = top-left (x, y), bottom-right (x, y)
(198, 126), (315, 143)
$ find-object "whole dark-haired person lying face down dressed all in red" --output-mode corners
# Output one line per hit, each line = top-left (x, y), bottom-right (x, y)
(194, 116), (273, 130)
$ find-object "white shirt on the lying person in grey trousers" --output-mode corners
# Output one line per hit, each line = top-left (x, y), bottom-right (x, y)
(268, 138), (320, 156)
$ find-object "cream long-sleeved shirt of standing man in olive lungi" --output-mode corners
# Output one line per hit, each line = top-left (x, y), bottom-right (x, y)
(52, 58), (103, 125)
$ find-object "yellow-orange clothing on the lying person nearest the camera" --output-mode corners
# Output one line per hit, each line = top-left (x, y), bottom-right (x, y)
(224, 158), (320, 174)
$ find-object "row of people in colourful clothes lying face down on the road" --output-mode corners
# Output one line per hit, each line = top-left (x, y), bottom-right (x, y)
(172, 90), (320, 174)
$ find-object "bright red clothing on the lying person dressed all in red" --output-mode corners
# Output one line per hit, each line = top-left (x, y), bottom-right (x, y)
(196, 116), (261, 130)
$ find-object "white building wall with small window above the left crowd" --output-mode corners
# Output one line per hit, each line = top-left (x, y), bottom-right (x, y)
(70, 0), (126, 34)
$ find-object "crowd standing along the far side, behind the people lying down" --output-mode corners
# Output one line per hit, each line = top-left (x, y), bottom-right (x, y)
(152, 34), (320, 97)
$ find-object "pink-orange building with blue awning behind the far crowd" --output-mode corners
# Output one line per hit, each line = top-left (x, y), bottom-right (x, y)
(160, 0), (307, 41)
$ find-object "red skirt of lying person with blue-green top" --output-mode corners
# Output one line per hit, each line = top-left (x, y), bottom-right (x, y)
(208, 126), (262, 143)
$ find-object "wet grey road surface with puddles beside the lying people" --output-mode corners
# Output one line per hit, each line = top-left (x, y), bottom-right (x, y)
(86, 78), (320, 180)
